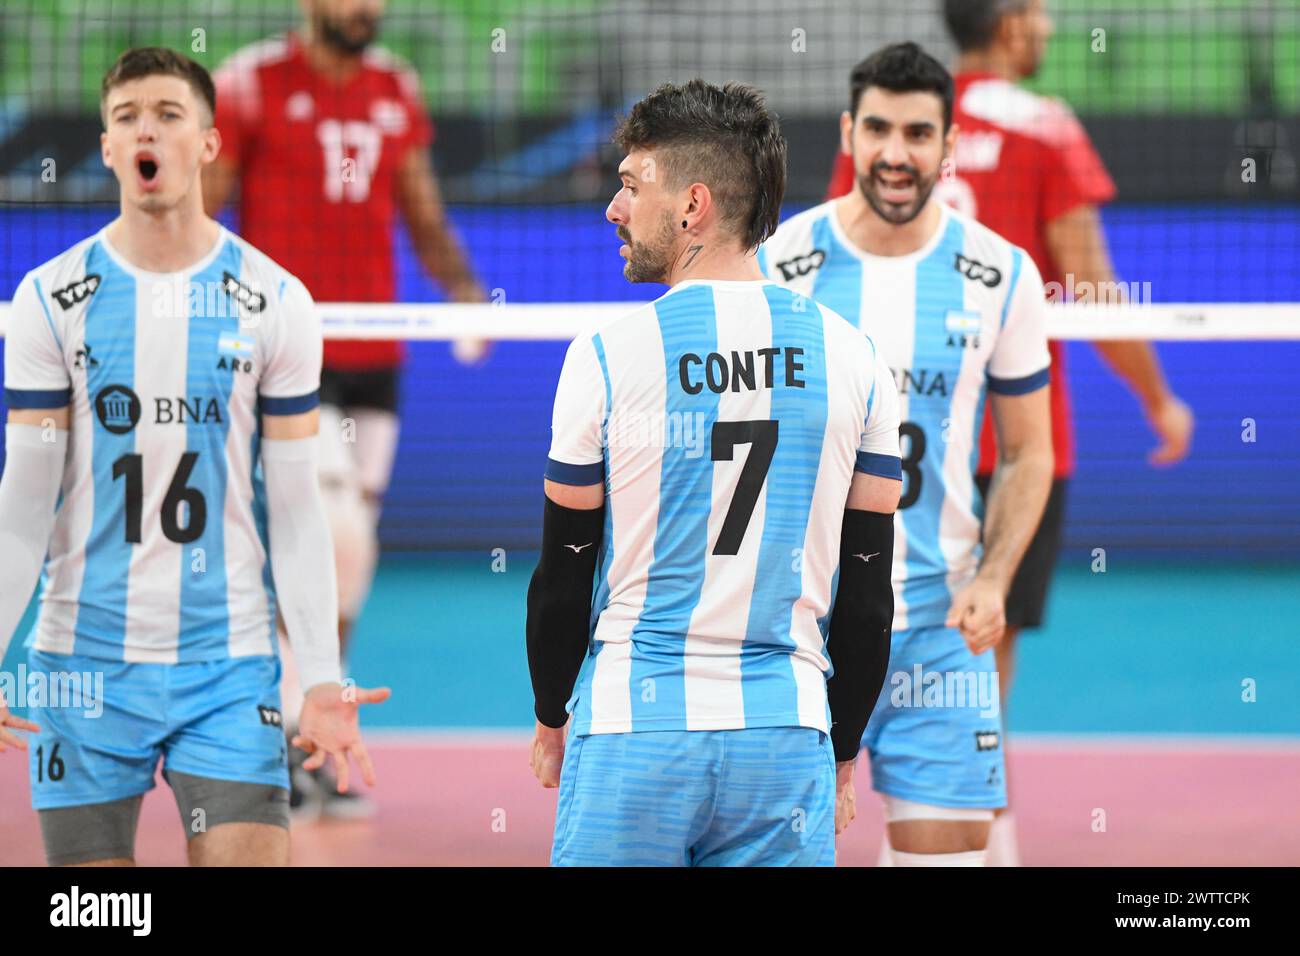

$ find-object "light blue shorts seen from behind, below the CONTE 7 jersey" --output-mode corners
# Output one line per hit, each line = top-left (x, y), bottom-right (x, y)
(551, 727), (835, 866)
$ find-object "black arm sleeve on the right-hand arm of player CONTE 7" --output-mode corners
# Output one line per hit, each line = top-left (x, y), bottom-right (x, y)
(826, 510), (893, 761)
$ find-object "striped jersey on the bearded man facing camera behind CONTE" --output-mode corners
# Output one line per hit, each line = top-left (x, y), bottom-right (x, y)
(758, 200), (1050, 631)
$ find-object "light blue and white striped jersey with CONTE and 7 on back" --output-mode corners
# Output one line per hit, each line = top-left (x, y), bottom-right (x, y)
(546, 280), (900, 734)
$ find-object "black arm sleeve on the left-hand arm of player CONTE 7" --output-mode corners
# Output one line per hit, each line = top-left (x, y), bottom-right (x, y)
(525, 498), (605, 727)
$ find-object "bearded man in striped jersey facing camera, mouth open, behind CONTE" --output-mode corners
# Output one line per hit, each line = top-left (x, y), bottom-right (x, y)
(759, 43), (1052, 866)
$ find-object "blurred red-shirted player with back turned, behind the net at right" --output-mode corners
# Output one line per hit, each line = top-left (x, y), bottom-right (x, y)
(829, 0), (1193, 866)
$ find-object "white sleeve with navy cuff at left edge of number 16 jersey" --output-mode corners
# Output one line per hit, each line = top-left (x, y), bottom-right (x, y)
(4, 274), (72, 408)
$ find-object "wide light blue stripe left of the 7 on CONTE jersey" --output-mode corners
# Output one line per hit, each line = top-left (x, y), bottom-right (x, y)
(629, 285), (719, 730)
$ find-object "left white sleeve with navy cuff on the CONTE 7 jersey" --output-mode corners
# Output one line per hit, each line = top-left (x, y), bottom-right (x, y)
(546, 336), (608, 485)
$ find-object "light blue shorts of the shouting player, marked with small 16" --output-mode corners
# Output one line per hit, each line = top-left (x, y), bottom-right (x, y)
(27, 650), (289, 810)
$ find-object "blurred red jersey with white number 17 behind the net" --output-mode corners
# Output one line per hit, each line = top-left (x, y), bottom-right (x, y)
(215, 34), (433, 369)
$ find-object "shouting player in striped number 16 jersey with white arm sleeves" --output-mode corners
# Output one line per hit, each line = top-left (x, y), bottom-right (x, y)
(0, 48), (387, 865)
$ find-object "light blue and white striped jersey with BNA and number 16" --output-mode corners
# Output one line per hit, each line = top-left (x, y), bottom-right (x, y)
(4, 229), (321, 663)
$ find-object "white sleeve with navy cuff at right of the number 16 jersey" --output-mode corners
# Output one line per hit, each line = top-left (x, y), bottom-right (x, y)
(257, 276), (324, 415)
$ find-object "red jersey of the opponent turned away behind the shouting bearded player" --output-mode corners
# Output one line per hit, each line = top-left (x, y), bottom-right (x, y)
(828, 73), (1115, 477)
